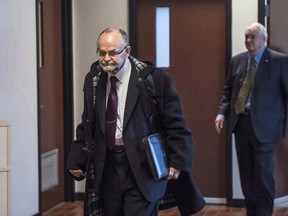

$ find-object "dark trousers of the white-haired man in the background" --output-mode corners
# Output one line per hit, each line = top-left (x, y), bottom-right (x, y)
(235, 115), (276, 216)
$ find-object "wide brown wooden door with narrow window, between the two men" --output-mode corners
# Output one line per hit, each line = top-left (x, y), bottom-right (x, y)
(130, 0), (227, 198)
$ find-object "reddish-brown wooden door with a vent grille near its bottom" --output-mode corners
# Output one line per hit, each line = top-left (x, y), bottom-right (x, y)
(37, 0), (65, 212)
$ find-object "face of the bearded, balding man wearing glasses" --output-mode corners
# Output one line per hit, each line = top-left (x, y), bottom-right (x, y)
(97, 31), (130, 74)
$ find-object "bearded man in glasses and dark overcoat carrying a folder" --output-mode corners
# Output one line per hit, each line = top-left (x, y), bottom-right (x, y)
(67, 28), (204, 216)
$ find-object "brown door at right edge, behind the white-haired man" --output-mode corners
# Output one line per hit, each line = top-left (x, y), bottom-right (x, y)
(267, 0), (288, 202)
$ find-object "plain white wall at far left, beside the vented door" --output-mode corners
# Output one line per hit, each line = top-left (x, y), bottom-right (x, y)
(0, 0), (39, 216)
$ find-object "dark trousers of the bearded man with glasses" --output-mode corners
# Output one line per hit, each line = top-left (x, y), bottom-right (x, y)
(101, 150), (158, 216)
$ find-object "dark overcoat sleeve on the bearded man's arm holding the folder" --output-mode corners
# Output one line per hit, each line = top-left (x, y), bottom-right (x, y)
(156, 72), (194, 172)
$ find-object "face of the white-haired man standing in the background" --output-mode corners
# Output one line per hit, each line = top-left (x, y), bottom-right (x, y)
(245, 27), (266, 55)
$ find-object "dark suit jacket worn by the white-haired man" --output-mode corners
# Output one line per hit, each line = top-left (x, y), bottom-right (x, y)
(218, 48), (288, 142)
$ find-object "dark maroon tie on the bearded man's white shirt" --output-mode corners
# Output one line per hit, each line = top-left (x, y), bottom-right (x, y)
(106, 76), (118, 149)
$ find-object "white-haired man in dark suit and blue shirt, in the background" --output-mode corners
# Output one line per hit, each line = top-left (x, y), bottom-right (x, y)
(215, 23), (288, 216)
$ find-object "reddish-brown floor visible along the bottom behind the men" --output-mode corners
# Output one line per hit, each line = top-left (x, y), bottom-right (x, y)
(43, 201), (288, 216)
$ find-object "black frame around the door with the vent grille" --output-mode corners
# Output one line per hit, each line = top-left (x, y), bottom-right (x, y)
(35, 0), (75, 214)
